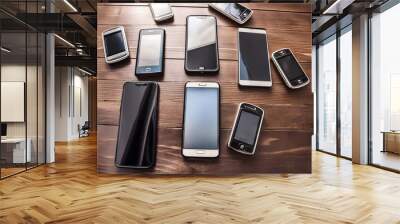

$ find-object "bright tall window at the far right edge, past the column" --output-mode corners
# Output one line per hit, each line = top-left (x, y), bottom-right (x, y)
(369, 4), (400, 170)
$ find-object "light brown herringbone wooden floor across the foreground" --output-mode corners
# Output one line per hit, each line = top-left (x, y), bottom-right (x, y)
(0, 137), (400, 223)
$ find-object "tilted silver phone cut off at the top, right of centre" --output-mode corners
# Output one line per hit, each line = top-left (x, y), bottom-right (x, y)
(208, 3), (253, 24)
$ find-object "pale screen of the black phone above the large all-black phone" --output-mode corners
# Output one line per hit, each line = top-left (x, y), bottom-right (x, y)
(138, 34), (162, 66)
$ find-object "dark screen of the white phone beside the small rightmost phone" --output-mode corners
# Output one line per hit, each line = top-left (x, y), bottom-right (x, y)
(239, 32), (271, 81)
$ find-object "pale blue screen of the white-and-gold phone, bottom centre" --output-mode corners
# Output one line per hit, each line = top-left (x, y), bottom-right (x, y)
(183, 87), (219, 149)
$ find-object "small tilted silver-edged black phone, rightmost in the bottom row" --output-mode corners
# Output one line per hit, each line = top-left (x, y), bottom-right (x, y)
(228, 103), (264, 155)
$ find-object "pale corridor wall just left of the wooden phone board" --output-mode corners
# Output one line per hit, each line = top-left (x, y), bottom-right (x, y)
(55, 67), (88, 141)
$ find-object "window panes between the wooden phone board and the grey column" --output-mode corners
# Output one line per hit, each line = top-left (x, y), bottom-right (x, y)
(316, 25), (352, 159)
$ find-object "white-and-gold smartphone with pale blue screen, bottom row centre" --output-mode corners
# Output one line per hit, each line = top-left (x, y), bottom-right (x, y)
(182, 82), (220, 157)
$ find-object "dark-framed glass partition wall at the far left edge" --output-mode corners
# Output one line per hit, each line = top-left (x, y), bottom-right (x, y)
(0, 1), (46, 179)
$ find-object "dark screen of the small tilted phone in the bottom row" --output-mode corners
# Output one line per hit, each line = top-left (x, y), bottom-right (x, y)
(233, 110), (260, 145)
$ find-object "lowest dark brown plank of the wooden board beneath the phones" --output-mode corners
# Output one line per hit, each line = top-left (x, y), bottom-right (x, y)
(97, 125), (311, 175)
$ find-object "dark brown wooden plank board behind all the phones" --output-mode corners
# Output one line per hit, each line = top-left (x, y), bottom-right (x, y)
(97, 3), (313, 175)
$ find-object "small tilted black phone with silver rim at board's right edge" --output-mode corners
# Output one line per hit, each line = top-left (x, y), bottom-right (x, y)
(272, 48), (310, 89)
